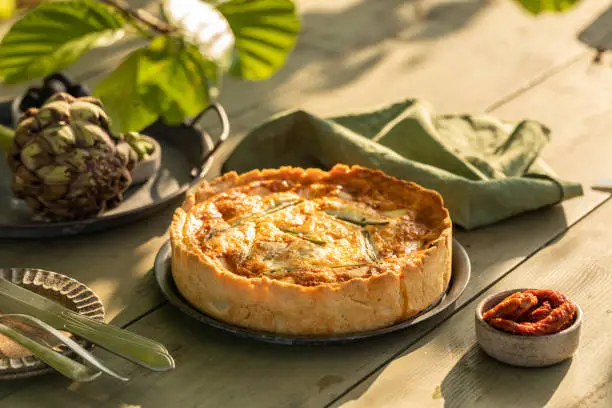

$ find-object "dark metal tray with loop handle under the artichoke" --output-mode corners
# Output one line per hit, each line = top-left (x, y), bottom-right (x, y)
(0, 104), (229, 238)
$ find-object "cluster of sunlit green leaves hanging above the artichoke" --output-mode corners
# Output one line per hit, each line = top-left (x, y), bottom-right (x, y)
(0, 0), (300, 132)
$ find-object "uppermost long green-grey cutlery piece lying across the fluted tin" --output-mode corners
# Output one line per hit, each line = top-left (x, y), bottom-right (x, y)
(0, 278), (174, 371)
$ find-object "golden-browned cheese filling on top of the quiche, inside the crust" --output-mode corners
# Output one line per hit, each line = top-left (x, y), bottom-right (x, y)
(186, 173), (446, 286)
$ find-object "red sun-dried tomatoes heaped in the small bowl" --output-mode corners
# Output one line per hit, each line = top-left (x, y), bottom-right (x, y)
(482, 289), (576, 336)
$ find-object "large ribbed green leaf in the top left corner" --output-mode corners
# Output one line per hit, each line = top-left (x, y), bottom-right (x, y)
(0, 0), (125, 84)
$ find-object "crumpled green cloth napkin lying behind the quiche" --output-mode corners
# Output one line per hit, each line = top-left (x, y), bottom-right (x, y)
(224, 99), (582, 229)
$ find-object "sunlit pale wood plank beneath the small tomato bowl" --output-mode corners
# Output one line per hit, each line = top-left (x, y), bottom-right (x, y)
(334, 201), (612, 408)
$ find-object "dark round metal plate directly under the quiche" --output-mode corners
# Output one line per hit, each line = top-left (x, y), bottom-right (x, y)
(155, 240), (471, 345)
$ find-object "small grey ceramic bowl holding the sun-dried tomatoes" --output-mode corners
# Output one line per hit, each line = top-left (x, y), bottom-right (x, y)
(476, 289), (582, 367)
